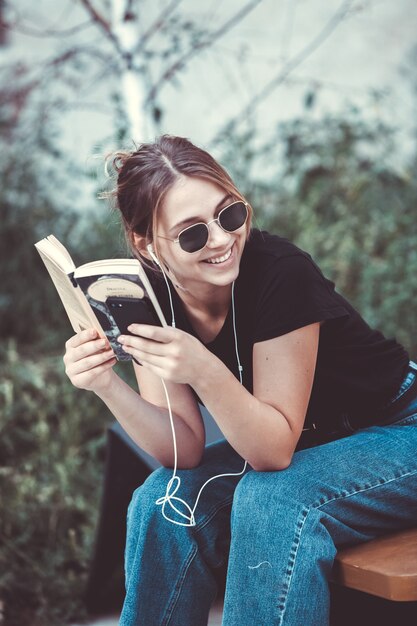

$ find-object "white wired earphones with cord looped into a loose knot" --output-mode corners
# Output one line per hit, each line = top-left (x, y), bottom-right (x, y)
(146, 251), (247, 526)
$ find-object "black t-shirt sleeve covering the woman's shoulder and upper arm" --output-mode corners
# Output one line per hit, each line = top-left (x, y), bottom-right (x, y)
(254, 254), (349, 343)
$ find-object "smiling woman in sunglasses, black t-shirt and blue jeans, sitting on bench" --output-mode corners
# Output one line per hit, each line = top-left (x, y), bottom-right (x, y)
(64, 136), (417, 626)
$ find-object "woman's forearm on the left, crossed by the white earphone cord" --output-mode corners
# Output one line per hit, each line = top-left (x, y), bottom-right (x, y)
(95, 374), (204, 469)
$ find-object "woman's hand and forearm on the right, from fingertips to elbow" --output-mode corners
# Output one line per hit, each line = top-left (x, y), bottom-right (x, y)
(113, 324), (302, 471)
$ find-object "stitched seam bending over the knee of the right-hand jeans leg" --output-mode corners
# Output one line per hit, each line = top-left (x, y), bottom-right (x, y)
(278, 469), (417, 624)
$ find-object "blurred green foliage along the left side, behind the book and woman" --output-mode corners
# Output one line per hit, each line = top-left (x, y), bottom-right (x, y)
(0, 113), (129, 626)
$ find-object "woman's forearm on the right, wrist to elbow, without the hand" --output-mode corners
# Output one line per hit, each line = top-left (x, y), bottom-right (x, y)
(193, 355), (295, 471)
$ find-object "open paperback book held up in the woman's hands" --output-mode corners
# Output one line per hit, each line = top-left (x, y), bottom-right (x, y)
(35, 235), (167, 361)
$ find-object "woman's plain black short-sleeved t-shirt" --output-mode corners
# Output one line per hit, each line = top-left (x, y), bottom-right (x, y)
(145, 229), (409, 428)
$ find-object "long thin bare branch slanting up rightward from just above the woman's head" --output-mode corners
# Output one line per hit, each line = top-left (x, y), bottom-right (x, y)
(211, 0), (355, 145)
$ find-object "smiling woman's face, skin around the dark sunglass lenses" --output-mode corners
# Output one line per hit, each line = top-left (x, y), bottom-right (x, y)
(155, 176), (247, 292)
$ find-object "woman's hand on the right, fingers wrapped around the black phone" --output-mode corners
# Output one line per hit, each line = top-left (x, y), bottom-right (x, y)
(118, 324), (207, 386)
